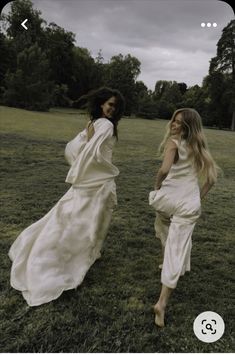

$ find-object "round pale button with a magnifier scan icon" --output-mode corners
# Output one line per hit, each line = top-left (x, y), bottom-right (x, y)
(193, 311), (225, 343)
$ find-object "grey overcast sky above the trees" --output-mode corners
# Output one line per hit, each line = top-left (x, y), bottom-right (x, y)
(3, 0), (234, 89)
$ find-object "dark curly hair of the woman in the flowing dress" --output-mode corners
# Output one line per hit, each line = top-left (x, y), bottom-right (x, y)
(79, 86), (125, 138)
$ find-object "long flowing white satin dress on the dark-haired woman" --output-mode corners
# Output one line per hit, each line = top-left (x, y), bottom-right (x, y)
(9, 118), (119, 306)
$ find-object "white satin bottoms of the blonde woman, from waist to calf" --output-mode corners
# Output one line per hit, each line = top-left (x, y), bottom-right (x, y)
(149, 189), (201, 288)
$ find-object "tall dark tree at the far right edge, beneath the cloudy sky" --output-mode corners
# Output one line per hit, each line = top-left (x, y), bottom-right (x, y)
(209, 20), (235, 130)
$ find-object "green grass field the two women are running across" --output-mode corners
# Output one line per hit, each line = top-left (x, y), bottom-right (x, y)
(0, 107), (235, 353)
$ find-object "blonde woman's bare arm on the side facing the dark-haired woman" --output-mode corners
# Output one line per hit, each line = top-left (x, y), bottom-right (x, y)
(155, 139), (178, 190)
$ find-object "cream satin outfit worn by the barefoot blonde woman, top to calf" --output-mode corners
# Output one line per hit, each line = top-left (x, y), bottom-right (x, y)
(149, 139), (201, 288)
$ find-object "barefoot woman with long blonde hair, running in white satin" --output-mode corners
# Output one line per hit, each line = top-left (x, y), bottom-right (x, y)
(149, 108), (218, 327)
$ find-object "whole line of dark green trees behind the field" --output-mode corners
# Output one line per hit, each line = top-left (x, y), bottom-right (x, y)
(0, 0), (235, 130)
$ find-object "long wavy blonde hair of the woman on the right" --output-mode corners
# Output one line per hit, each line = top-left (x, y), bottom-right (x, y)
(159, 108), (220, 183)
